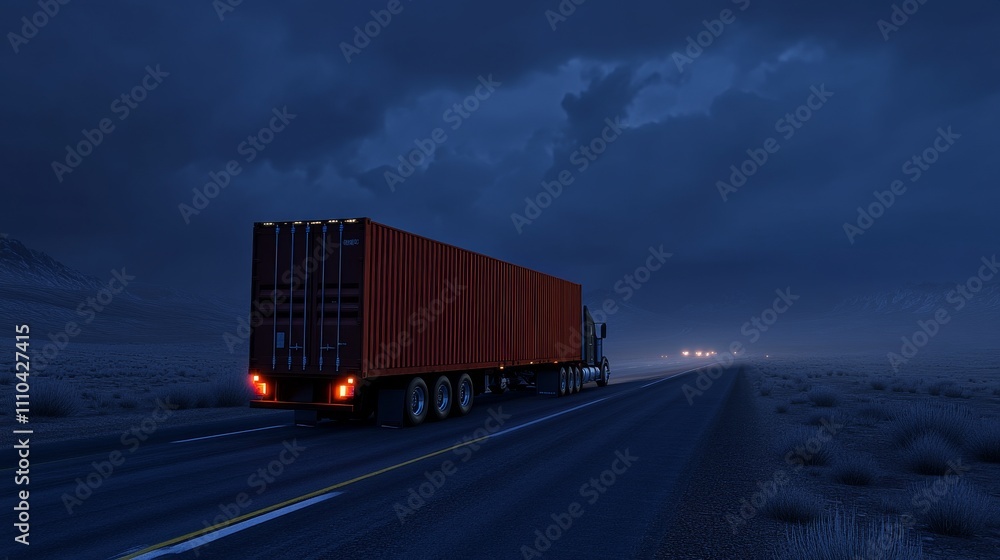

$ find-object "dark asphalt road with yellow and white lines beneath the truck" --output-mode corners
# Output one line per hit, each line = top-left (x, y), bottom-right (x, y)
(2, 364), (733, 560)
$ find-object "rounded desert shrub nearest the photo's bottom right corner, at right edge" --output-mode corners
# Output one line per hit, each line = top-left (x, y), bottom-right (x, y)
(915, 480), (1000, 537)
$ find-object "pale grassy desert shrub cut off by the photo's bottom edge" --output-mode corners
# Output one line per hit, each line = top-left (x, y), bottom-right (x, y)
(777, 511), (923, 560)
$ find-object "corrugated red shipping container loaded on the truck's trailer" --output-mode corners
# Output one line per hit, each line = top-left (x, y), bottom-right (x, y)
(250, 218), (582, 377)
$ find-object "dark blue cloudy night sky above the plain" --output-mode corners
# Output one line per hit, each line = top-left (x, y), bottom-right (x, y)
(0, 0), (1000, 312)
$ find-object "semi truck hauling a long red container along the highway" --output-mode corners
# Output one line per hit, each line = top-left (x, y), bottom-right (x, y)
(248, 218), (611, 427)
